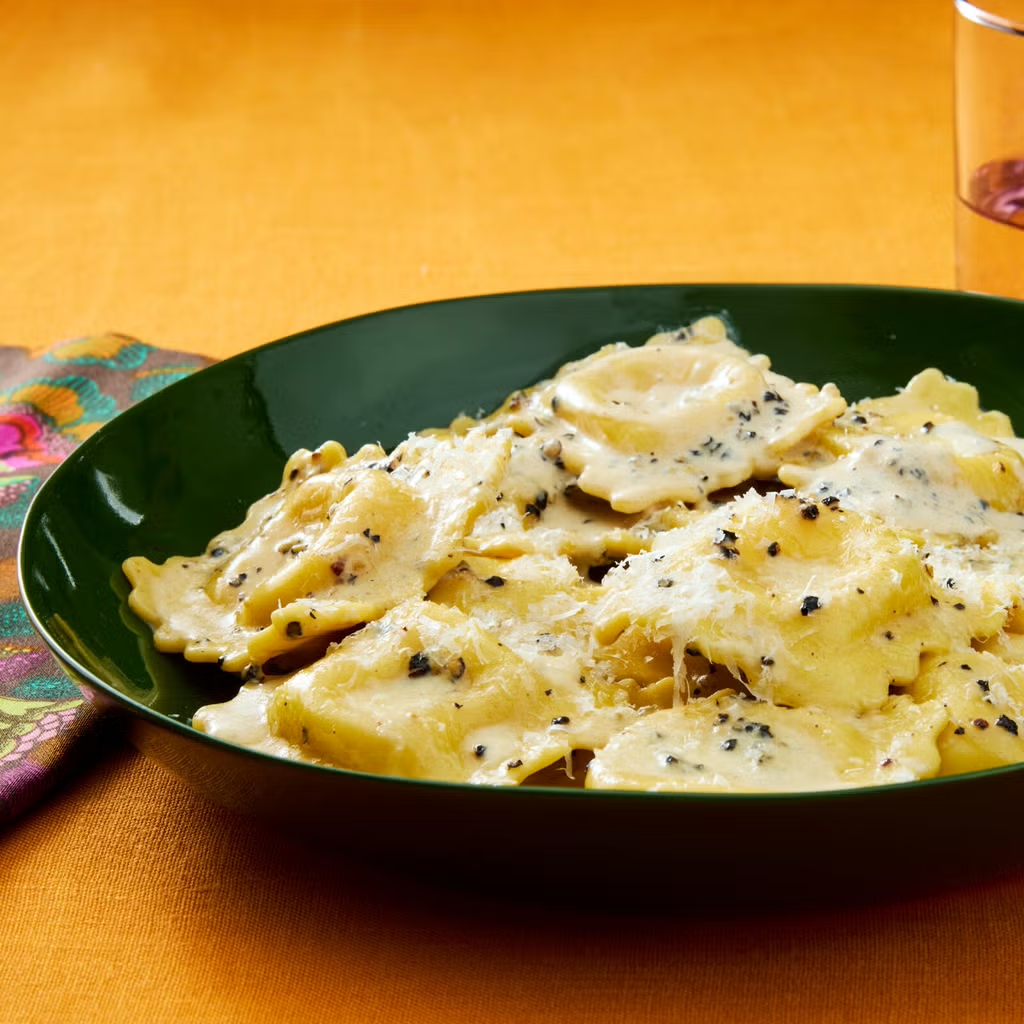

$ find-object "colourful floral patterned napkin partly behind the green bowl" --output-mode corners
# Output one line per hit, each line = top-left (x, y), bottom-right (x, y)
(0, 334), (209, 825)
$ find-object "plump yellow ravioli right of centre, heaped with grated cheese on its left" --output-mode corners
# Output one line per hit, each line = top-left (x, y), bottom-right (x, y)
(594, 490), (949, 711)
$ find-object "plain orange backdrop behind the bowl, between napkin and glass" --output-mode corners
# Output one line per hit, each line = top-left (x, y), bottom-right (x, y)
(6, 0), (953, 353)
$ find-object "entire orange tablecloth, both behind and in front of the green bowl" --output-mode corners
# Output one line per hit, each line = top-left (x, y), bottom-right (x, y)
(8, 0), (1024, 1024)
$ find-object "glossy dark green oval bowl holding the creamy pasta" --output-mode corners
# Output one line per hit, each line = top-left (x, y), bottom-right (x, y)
(19, 285), (1024, 909)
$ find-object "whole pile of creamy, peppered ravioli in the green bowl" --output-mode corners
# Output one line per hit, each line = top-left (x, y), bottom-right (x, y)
(124, 317), (1024, 792)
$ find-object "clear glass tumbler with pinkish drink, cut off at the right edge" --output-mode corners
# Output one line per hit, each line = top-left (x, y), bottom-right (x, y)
(954, 0), (1024, 299)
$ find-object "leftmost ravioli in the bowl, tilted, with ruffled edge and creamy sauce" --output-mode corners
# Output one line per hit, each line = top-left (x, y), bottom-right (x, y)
(125, 430), (511, 676)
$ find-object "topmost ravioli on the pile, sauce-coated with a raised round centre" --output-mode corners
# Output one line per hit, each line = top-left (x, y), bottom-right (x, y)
(487, 317), (846, 513)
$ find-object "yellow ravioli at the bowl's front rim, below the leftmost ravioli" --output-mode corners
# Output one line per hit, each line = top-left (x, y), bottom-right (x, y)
(268, 600), (635, 784)
